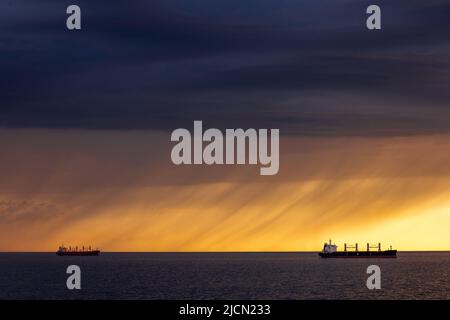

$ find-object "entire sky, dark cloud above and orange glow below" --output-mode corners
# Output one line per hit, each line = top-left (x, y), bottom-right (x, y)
(0, 0), (450, 251)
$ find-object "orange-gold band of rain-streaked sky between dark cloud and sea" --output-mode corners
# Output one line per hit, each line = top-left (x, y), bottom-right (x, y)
(0, 129), (450, 251)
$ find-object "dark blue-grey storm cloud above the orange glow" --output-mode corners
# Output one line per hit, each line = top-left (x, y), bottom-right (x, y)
(0, 0), (450, 135)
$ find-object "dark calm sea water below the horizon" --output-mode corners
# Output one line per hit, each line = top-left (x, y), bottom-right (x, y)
(0, 252), (450, 299)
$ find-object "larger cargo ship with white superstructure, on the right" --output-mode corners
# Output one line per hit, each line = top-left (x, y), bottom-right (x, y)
(319, 240), (397, 258)
